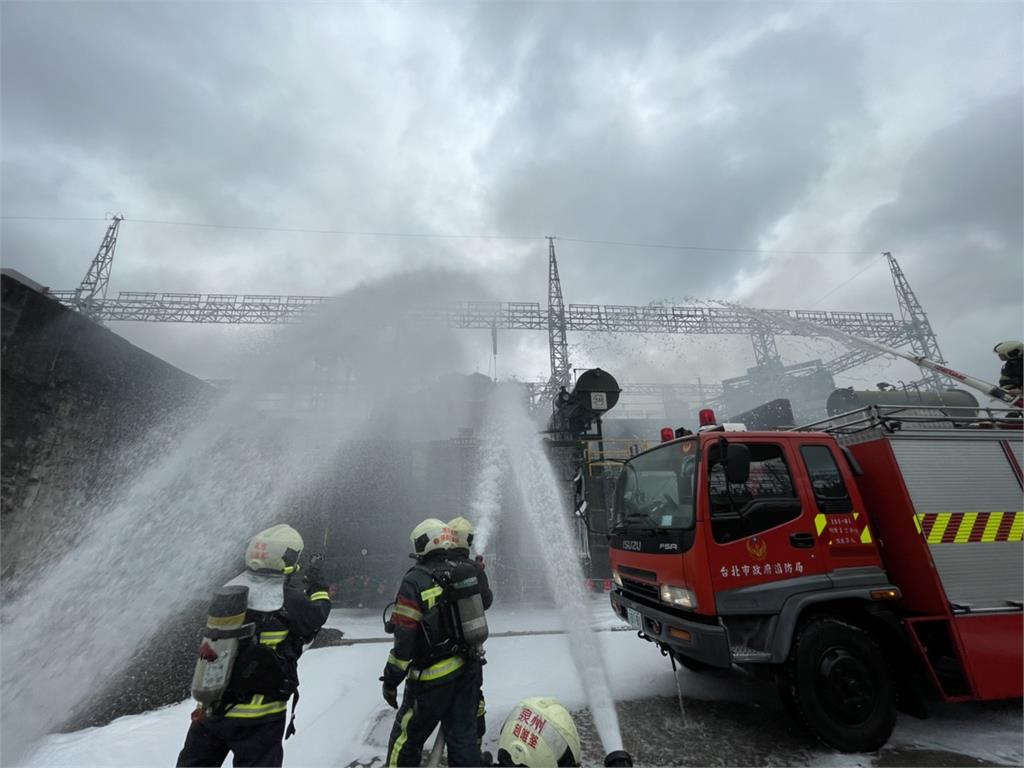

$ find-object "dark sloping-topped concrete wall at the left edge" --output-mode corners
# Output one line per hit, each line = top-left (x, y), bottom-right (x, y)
(0, 269), (214, 591)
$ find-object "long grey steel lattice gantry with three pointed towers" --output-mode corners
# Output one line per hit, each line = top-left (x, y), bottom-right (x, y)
(44, 215), (942, 393)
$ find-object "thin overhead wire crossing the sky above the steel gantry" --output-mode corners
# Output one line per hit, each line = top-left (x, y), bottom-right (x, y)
(0, 216), (876, 256)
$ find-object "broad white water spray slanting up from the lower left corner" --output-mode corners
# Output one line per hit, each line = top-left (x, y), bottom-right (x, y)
(0, 273), (495, 765)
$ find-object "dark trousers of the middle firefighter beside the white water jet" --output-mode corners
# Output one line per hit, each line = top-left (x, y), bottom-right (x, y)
(387, 665), (480, 766)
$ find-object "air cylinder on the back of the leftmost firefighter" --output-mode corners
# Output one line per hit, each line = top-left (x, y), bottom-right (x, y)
(193, 586), (249, 705)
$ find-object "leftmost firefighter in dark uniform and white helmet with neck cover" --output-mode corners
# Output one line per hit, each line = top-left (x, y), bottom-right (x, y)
(177, 525), (331, 766)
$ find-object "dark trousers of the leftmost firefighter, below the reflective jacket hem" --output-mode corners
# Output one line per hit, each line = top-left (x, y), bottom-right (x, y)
(177, 714), (285, 768)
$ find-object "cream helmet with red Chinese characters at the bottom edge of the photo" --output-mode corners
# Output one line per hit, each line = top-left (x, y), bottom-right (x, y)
(498, 696), (581, 768)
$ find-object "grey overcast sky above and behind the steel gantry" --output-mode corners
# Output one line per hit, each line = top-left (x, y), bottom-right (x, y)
(0, 2), (1024, 403)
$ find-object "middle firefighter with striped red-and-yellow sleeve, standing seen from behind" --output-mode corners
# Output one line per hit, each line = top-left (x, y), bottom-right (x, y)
(381, 518), (486, 766)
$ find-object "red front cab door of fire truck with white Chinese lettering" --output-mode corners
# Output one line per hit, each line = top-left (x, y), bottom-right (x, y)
(701, 437), (828, 602)
